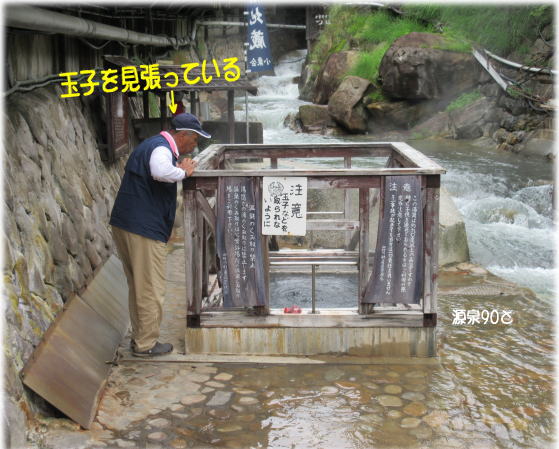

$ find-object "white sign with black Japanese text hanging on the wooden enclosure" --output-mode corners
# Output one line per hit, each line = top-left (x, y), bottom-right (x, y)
(262, 177), (307, 235)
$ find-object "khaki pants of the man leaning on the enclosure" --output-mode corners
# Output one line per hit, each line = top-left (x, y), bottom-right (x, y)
(112, 226), (166, 351)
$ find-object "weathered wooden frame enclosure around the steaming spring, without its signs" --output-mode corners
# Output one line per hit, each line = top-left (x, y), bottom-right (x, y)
(183, 142), (446, 327)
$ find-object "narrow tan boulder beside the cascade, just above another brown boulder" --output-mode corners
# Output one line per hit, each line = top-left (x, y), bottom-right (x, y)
(312, 51), (359, 104)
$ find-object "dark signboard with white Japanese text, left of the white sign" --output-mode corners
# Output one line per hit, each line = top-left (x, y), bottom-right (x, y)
(217, 176), (267, 308)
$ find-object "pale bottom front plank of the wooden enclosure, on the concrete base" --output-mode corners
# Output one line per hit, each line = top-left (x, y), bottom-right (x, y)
(200, 309), (423, 328)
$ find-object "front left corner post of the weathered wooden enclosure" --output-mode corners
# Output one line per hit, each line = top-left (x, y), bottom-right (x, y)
(183, 188), (201, 327)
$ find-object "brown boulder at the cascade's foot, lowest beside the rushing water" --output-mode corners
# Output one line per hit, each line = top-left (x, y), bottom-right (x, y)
(328, 76), (371, 133)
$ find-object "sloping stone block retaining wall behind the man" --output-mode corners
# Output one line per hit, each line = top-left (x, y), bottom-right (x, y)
(3, 86), (124, 447)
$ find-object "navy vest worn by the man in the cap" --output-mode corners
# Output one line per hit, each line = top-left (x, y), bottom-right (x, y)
(110, 135), (177, 243)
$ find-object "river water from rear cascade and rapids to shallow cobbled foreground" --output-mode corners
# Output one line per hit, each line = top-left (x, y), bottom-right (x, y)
(228, 51), (556, 448)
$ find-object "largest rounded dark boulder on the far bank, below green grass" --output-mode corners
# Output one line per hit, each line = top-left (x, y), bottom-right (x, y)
(379, 32), (481, 100)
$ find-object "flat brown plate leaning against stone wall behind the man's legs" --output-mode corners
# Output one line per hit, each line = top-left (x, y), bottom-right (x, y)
(22, 256), (128, 429)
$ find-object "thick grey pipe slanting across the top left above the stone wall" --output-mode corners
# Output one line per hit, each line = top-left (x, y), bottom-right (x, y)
(5, 6), (190, 47)
